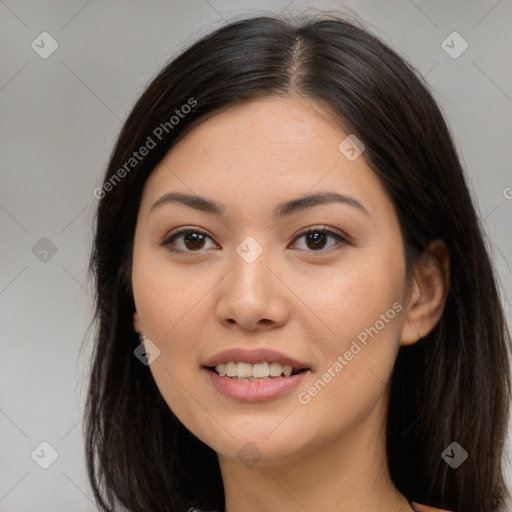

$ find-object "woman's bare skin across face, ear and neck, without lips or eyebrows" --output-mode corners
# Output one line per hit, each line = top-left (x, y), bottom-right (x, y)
(132, 97), (449, 512)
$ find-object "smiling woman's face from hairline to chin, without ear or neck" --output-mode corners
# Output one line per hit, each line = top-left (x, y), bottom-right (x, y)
(132, 98), (412, 464)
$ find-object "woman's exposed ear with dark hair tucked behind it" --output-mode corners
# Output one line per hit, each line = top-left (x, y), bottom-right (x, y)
(400, 240), (450, 345)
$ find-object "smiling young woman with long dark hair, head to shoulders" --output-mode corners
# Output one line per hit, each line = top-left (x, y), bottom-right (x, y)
(86, 15), (510, 512)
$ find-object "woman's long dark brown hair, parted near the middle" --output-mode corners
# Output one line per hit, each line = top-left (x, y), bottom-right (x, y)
(86, 14), (510, 512)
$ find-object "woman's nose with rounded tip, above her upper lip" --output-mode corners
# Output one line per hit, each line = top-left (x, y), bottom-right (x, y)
(216, 247), (290, 331)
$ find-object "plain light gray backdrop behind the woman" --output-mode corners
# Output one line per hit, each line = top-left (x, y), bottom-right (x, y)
(0, 0), (512, 512)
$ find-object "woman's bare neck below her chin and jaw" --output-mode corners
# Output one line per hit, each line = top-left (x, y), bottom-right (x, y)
(219, 398), (410, 512)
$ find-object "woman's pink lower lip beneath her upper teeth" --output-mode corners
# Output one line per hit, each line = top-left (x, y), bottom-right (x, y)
(203, 368), (310, 402)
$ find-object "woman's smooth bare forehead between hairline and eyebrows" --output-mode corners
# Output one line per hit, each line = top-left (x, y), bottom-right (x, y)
(140, 97), (389, 222)
